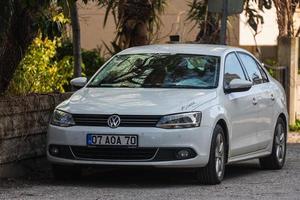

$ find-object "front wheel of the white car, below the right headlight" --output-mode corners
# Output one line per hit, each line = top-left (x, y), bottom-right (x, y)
(197, 124), (226, 185)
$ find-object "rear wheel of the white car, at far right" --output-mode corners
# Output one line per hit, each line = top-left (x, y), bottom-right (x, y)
(259, 118), (287, 170)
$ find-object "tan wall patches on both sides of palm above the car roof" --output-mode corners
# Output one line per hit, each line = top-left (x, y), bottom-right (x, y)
(79, 0), (197, 49)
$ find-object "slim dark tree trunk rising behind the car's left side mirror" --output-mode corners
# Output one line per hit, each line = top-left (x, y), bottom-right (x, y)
(70, 2), (82, 78)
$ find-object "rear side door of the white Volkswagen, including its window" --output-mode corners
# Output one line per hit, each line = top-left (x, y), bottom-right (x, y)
(238, 52), (275, 150)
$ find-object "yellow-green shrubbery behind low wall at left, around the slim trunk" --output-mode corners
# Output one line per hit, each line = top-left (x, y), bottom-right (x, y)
(7, 19), (104, 95)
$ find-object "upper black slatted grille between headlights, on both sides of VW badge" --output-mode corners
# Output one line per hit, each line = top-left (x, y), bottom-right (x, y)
(73, 114), (161, 127)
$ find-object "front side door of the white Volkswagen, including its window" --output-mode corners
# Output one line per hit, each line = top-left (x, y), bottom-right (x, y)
(223, 52), (258, 157)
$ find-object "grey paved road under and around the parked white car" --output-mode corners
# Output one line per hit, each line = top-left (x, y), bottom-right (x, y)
(0, 144), (300, 200)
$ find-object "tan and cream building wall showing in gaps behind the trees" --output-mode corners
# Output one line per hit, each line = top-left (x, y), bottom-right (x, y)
(79, 0), (300, 50)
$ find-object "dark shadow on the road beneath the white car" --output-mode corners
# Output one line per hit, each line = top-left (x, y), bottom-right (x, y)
(47, 161), (261, 188)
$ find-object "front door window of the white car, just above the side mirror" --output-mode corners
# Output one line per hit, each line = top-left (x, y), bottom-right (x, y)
(224, 53), (246, 87)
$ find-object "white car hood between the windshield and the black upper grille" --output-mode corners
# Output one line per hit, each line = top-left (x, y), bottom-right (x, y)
(57, 88), (216, 115)
